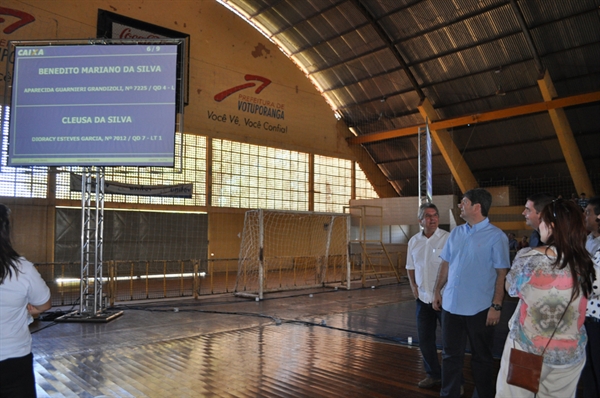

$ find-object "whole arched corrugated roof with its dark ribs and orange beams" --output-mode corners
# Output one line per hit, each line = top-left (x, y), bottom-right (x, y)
(220, 0), (600, 197)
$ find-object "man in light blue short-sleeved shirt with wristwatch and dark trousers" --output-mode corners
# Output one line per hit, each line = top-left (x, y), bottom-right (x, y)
(433, 188), (510, 398)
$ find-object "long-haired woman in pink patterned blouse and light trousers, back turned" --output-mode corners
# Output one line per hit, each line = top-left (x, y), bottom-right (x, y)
(496, 200), (594, 398)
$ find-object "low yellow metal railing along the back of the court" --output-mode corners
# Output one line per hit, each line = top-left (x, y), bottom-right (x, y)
(36, 253), (400, 306)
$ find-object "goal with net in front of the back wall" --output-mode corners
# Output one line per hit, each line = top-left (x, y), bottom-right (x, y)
(235, 210), (350, 299)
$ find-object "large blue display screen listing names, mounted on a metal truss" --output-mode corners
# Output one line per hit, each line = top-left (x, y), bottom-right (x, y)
(8, 42), (179, 167)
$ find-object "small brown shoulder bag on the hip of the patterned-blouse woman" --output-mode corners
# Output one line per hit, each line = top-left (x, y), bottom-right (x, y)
(506, 348), (544, 394)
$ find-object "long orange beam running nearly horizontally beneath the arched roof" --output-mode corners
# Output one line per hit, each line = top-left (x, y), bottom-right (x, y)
(348, 91), (600, 145)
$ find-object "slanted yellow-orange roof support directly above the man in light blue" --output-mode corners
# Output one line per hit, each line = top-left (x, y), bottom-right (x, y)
(419, 98), (479, 192)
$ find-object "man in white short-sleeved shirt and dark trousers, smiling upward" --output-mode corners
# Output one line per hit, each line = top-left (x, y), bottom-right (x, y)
(406, 203), (450, 388)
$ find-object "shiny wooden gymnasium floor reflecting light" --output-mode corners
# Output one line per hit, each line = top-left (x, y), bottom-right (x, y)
(31, 284), (514, 398)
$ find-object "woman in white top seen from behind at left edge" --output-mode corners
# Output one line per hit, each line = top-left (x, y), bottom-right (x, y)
(0, 204), (51, 398)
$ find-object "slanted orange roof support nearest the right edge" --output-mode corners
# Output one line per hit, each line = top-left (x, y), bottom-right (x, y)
(538, 70), (595, 197)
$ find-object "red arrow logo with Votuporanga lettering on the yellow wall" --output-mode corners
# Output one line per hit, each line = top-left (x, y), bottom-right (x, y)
(214, 75), (285, 120)
